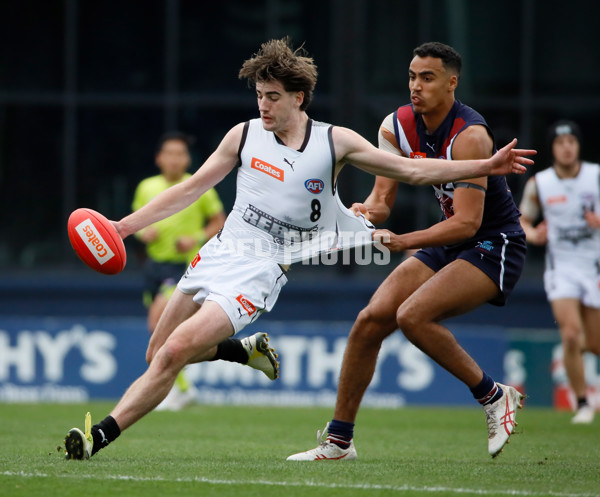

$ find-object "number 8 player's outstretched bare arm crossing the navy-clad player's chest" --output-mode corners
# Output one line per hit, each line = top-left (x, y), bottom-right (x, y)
(333, 127), (536, 185)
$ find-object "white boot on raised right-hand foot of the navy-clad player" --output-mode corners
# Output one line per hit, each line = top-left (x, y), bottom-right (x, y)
(483, 383), (525, 457)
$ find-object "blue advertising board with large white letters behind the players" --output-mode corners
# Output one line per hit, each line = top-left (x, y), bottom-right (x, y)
(0, 317), (555, 407)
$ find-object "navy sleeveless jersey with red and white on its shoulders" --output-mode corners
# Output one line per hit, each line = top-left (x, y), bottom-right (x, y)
(394, 100), (522, 238)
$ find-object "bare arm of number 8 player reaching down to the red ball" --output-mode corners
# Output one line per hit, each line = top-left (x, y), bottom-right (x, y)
(114, 123), (244, 238)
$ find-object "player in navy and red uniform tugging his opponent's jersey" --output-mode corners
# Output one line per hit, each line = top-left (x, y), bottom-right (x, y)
(288, 42), (526, 461)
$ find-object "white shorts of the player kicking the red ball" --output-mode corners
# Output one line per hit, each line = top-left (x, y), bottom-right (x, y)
(177, 236), (287, 333)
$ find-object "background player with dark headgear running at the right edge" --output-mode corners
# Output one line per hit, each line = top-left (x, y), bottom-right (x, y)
(520, 120), (600, 424)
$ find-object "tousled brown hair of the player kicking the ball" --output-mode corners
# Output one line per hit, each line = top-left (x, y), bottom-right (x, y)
(238, 36), (318, 110)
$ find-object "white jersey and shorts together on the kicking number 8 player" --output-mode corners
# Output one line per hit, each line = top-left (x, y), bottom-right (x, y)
(178, 119), (374, 332)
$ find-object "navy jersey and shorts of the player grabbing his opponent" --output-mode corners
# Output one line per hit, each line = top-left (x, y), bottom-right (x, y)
(384, 100), (526, 305)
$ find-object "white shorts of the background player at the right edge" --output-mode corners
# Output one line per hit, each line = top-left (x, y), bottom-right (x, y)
(544, 261), (600, 308)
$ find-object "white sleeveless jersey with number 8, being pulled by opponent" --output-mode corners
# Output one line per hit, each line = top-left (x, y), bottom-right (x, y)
(220, 119), (374, 264)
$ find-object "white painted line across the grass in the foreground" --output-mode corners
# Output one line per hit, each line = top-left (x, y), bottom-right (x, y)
(0, 471), (600, 497)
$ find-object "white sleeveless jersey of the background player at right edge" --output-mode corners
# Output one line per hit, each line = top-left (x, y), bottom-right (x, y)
(535, 162), (600, 266)
